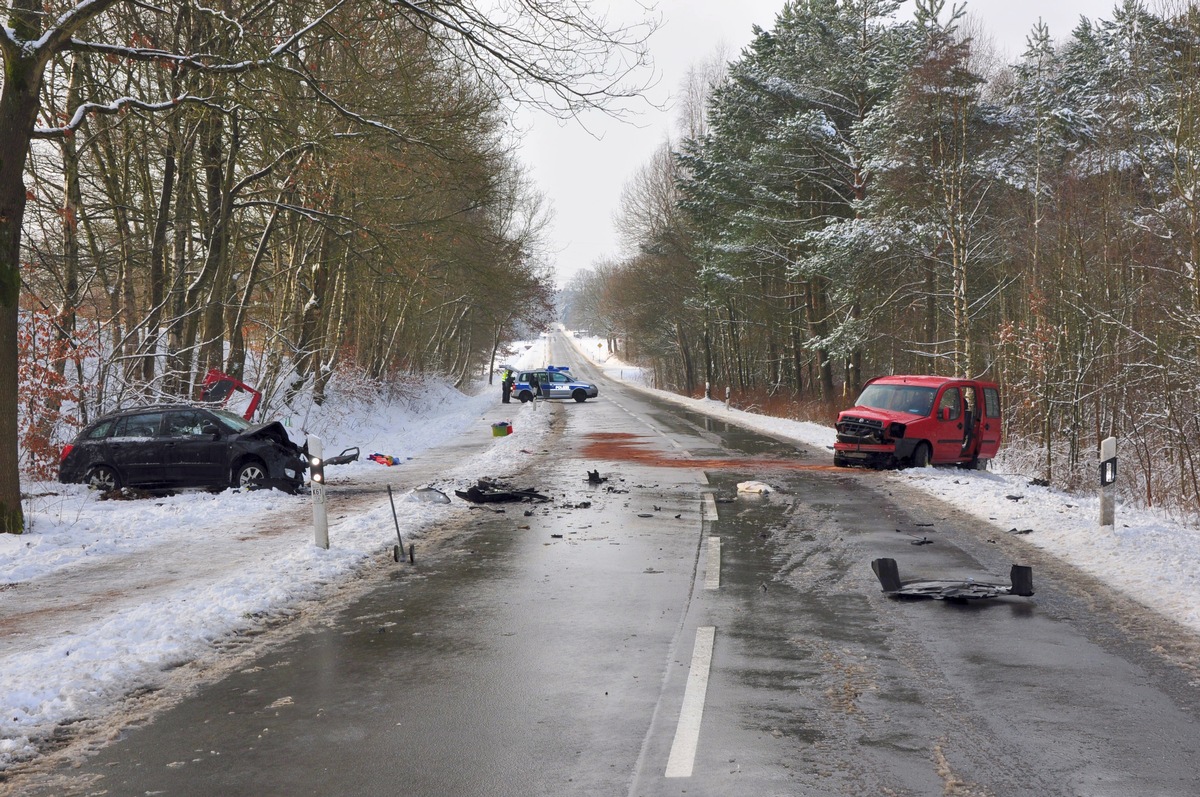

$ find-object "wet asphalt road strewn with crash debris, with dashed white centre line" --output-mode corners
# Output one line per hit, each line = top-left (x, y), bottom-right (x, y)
(9, 333), (1200, 797)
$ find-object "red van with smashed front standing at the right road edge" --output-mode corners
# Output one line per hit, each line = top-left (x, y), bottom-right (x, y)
(833, 376), (1001, 471)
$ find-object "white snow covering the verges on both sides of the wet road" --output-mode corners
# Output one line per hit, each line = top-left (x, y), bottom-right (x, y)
(0, 338), (1200, 771)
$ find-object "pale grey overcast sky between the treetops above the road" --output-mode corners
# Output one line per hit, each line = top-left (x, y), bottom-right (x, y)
(521, 0), (1116, 284)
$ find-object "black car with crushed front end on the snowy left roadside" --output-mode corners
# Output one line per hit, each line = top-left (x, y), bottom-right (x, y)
(59, 405), (306, 492)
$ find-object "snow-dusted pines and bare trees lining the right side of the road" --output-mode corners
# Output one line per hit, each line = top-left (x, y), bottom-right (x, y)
(563, 0), (1200, 513)
